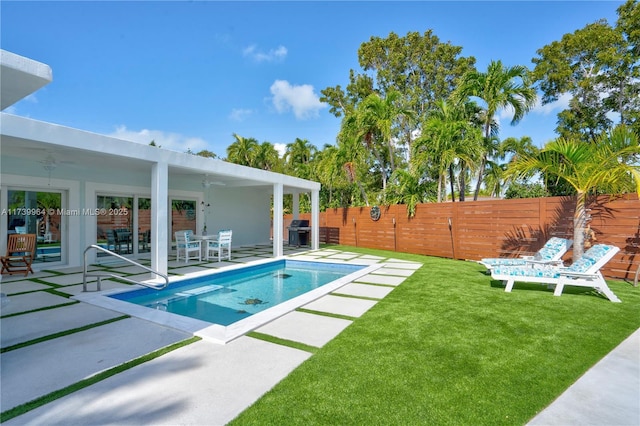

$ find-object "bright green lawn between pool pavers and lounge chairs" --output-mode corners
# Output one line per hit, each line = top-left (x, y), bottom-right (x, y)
(232, 247), (640, 425)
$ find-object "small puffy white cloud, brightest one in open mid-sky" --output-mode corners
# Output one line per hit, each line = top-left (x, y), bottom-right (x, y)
(270, 80), (327, 120)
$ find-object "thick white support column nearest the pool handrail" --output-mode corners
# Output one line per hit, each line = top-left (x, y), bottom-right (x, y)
(151, 163), (171, 274)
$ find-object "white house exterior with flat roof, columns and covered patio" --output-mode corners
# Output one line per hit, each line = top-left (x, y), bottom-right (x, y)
(0, 50), (320, 273)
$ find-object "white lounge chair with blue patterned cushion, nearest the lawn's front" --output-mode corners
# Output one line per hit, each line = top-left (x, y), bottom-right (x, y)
(491, 244), (620, 302)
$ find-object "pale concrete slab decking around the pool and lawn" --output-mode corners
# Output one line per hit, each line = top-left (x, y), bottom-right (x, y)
(0, 250), (640, 425)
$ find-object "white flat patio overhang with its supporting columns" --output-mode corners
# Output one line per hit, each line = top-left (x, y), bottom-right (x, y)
(0, 113), (320, 273)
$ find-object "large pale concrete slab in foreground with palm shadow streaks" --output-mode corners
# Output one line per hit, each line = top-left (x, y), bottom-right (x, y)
(3, 337), (311, 426)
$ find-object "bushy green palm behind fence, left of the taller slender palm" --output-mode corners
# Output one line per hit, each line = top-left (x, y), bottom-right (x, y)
(411, 100), (480, 202)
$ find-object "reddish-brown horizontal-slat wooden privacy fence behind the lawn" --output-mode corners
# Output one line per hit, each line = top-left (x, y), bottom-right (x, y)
(283, 195), (640, 280)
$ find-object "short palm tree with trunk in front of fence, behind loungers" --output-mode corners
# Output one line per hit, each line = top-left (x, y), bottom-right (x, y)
(507, 126), (640, 260)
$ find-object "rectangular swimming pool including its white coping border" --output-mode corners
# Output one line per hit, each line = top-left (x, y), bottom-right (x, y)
(74, 259), (382, 343)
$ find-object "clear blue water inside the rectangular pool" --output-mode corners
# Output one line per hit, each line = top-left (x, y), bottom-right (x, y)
(109, 260), (365, 326)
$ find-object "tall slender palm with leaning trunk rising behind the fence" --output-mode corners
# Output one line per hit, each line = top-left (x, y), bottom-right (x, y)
(456, 61), (536, 200)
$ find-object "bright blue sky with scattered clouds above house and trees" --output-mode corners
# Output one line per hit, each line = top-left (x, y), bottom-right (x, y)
(0, 0), (622, 157)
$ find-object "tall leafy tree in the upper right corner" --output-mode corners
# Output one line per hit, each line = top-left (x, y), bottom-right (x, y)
(533, 0), (640, 142)
